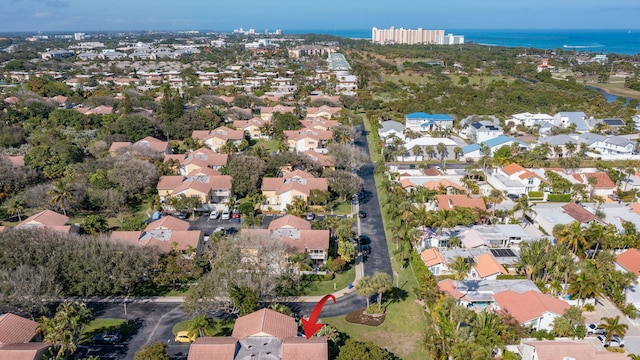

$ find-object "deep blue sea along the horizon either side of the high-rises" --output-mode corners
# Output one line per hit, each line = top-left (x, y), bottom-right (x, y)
(283, 29), (640, 55)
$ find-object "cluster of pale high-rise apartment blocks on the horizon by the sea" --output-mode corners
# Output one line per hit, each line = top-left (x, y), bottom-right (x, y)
(371, 26), (464, 45)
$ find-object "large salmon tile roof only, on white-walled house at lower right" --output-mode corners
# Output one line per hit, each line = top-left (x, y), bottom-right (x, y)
(493, 290), (569, 323)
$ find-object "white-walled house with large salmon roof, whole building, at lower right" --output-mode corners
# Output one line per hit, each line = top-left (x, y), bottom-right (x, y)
(493, 290), (569, 331)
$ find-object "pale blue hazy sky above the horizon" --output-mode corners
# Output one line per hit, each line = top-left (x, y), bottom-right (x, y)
(0, 0), (640, 32)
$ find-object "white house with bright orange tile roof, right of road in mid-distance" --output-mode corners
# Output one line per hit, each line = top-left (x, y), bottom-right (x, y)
(487, 163), (547, 195)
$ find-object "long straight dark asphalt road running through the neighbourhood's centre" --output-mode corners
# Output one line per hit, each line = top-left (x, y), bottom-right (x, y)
(355, 125), (393, 279)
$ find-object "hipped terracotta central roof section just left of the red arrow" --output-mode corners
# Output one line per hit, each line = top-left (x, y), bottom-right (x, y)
(231, 309), (298, 340)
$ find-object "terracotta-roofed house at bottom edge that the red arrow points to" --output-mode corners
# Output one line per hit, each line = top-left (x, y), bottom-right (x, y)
(187, 309), (329, 360)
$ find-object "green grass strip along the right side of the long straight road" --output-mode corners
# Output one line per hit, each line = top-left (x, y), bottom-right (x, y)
(322, 116), (429, 360)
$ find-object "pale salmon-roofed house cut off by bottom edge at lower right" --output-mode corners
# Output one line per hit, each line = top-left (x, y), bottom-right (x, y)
(518, 340), (628, 360)
